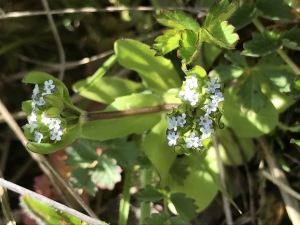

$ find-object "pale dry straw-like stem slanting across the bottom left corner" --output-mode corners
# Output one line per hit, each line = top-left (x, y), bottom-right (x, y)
(0, 178), (107, 225)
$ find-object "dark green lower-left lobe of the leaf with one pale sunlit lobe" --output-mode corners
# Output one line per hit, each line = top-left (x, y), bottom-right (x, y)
(70, 168), (98, 196)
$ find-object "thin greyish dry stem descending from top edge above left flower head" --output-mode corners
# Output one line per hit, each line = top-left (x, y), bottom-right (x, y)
(41, 0), (66, 80)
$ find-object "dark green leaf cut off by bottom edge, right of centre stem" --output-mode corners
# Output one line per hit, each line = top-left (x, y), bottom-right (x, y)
(144, 213), (189, 225)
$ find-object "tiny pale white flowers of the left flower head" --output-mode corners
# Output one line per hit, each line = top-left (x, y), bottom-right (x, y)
(25, 80), (63, 143)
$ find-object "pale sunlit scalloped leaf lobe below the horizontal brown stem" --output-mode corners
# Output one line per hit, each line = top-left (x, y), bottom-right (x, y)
(90, 154), (122, 190)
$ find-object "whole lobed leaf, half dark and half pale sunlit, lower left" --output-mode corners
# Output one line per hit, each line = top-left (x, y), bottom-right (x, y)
(66, 139), (121, 195)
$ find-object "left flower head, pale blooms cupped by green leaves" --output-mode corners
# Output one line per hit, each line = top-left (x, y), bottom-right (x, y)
(22, 72), (83, 154)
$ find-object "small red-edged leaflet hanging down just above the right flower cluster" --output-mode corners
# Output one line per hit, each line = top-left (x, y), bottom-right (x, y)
(177, 30), (202, 64)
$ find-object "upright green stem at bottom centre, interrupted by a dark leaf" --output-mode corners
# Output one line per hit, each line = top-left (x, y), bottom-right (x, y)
(139, 168), (152, 225)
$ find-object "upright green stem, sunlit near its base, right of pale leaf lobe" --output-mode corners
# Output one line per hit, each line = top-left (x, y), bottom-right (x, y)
(118, 170), (132, 225)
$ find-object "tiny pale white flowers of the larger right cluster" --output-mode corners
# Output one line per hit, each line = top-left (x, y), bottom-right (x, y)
(167, 75), (224, 149)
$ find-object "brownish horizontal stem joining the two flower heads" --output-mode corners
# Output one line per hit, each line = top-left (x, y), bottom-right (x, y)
(82, 104), (179, 121)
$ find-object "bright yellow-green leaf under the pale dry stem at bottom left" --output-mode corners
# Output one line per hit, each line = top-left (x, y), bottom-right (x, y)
(20, 196), (92, 225)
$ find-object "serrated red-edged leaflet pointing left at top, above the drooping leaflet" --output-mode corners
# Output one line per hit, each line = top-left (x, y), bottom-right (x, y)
(156, 10), (200, 32)
